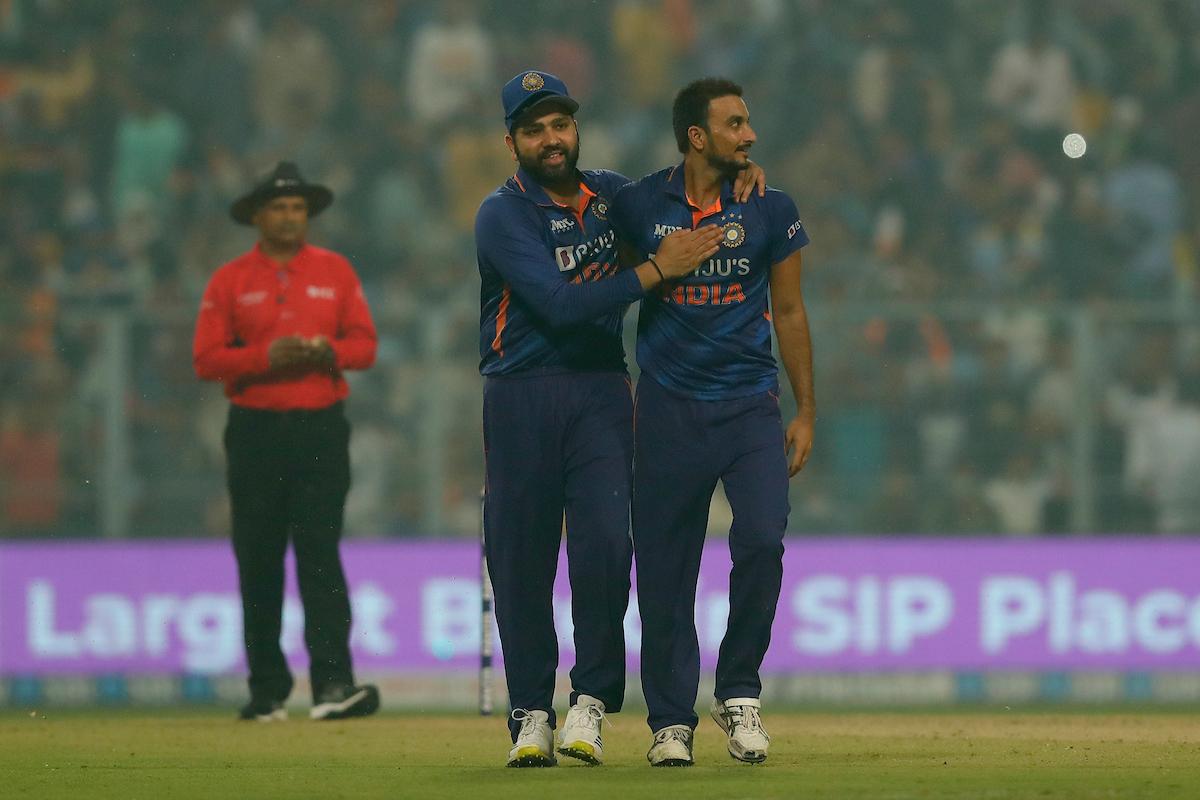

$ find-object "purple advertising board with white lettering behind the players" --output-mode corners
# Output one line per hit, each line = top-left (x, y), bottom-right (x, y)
(0, 539), (1200, 675)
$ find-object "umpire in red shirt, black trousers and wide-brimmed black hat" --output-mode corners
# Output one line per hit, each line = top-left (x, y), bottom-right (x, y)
(192, 162), (379, 721)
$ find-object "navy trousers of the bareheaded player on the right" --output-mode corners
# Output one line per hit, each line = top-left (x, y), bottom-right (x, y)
(632, 374), (788, 730)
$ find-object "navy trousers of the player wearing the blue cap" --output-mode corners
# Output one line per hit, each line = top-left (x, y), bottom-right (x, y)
(484, 372), (634, 741)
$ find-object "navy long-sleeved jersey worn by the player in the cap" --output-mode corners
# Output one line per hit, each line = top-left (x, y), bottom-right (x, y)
(475, 169), (643, 375)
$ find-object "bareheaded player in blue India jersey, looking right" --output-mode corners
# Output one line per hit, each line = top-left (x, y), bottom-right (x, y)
(611, 78), (815, 766)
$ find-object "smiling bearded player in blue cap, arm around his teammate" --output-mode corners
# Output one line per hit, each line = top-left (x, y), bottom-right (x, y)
(475, 70), (764, 766)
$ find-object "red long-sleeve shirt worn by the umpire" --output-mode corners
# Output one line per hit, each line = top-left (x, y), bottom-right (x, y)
(192, 245), (376, 411)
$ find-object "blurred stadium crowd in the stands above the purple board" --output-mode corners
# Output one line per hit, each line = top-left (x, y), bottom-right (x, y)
(0, 0), (1200, 536)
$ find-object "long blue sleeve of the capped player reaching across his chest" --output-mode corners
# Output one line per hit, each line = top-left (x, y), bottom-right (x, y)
(475, 198), (642, 327)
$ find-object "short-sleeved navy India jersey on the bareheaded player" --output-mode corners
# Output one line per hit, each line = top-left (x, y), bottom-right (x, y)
(612, 166), (809, 399)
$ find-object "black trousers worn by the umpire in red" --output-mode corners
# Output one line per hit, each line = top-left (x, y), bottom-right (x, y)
(224, 403), (354, 700)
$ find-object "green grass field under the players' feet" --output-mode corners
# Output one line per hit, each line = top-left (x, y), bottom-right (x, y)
(0, 709), (1200, 800)
